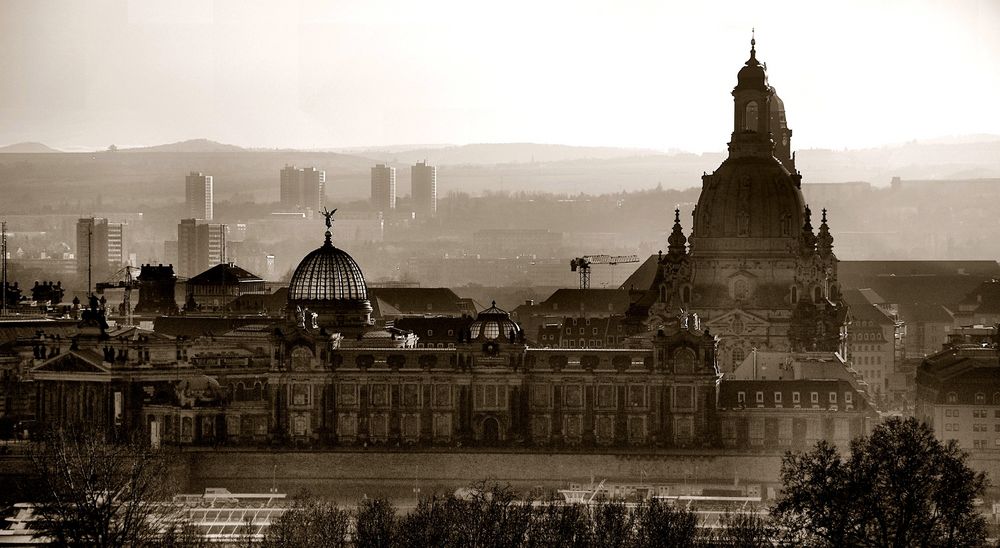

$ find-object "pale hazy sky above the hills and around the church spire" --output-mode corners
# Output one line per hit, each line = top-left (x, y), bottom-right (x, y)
(0, 0), (1000, 151)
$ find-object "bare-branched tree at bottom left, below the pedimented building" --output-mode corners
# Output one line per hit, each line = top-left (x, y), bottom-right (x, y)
(30, 429), (169, 547)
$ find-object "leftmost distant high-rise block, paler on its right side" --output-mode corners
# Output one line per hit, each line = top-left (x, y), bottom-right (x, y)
(76, 217), (125, 287)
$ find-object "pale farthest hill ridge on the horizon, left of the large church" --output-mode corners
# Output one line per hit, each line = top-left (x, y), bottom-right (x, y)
(341, 143), (662, 166)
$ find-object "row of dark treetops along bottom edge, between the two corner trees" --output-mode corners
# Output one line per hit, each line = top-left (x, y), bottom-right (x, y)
(262, 484), (776, 548)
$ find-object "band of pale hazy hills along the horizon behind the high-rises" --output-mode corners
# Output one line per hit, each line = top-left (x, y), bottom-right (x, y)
(0, 135), (1000, 211)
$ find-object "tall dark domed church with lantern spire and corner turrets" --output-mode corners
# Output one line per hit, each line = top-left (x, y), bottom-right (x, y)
(628, 41), (846, 371)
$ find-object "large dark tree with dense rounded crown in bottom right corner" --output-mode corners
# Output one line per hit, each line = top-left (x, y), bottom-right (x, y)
(773, 418), (987, 547)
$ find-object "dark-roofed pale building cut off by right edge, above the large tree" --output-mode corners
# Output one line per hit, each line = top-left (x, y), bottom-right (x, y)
(915, 328), (1000, 457)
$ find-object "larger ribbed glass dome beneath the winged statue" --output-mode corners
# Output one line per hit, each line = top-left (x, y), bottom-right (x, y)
(288, 238), (368, 301)
